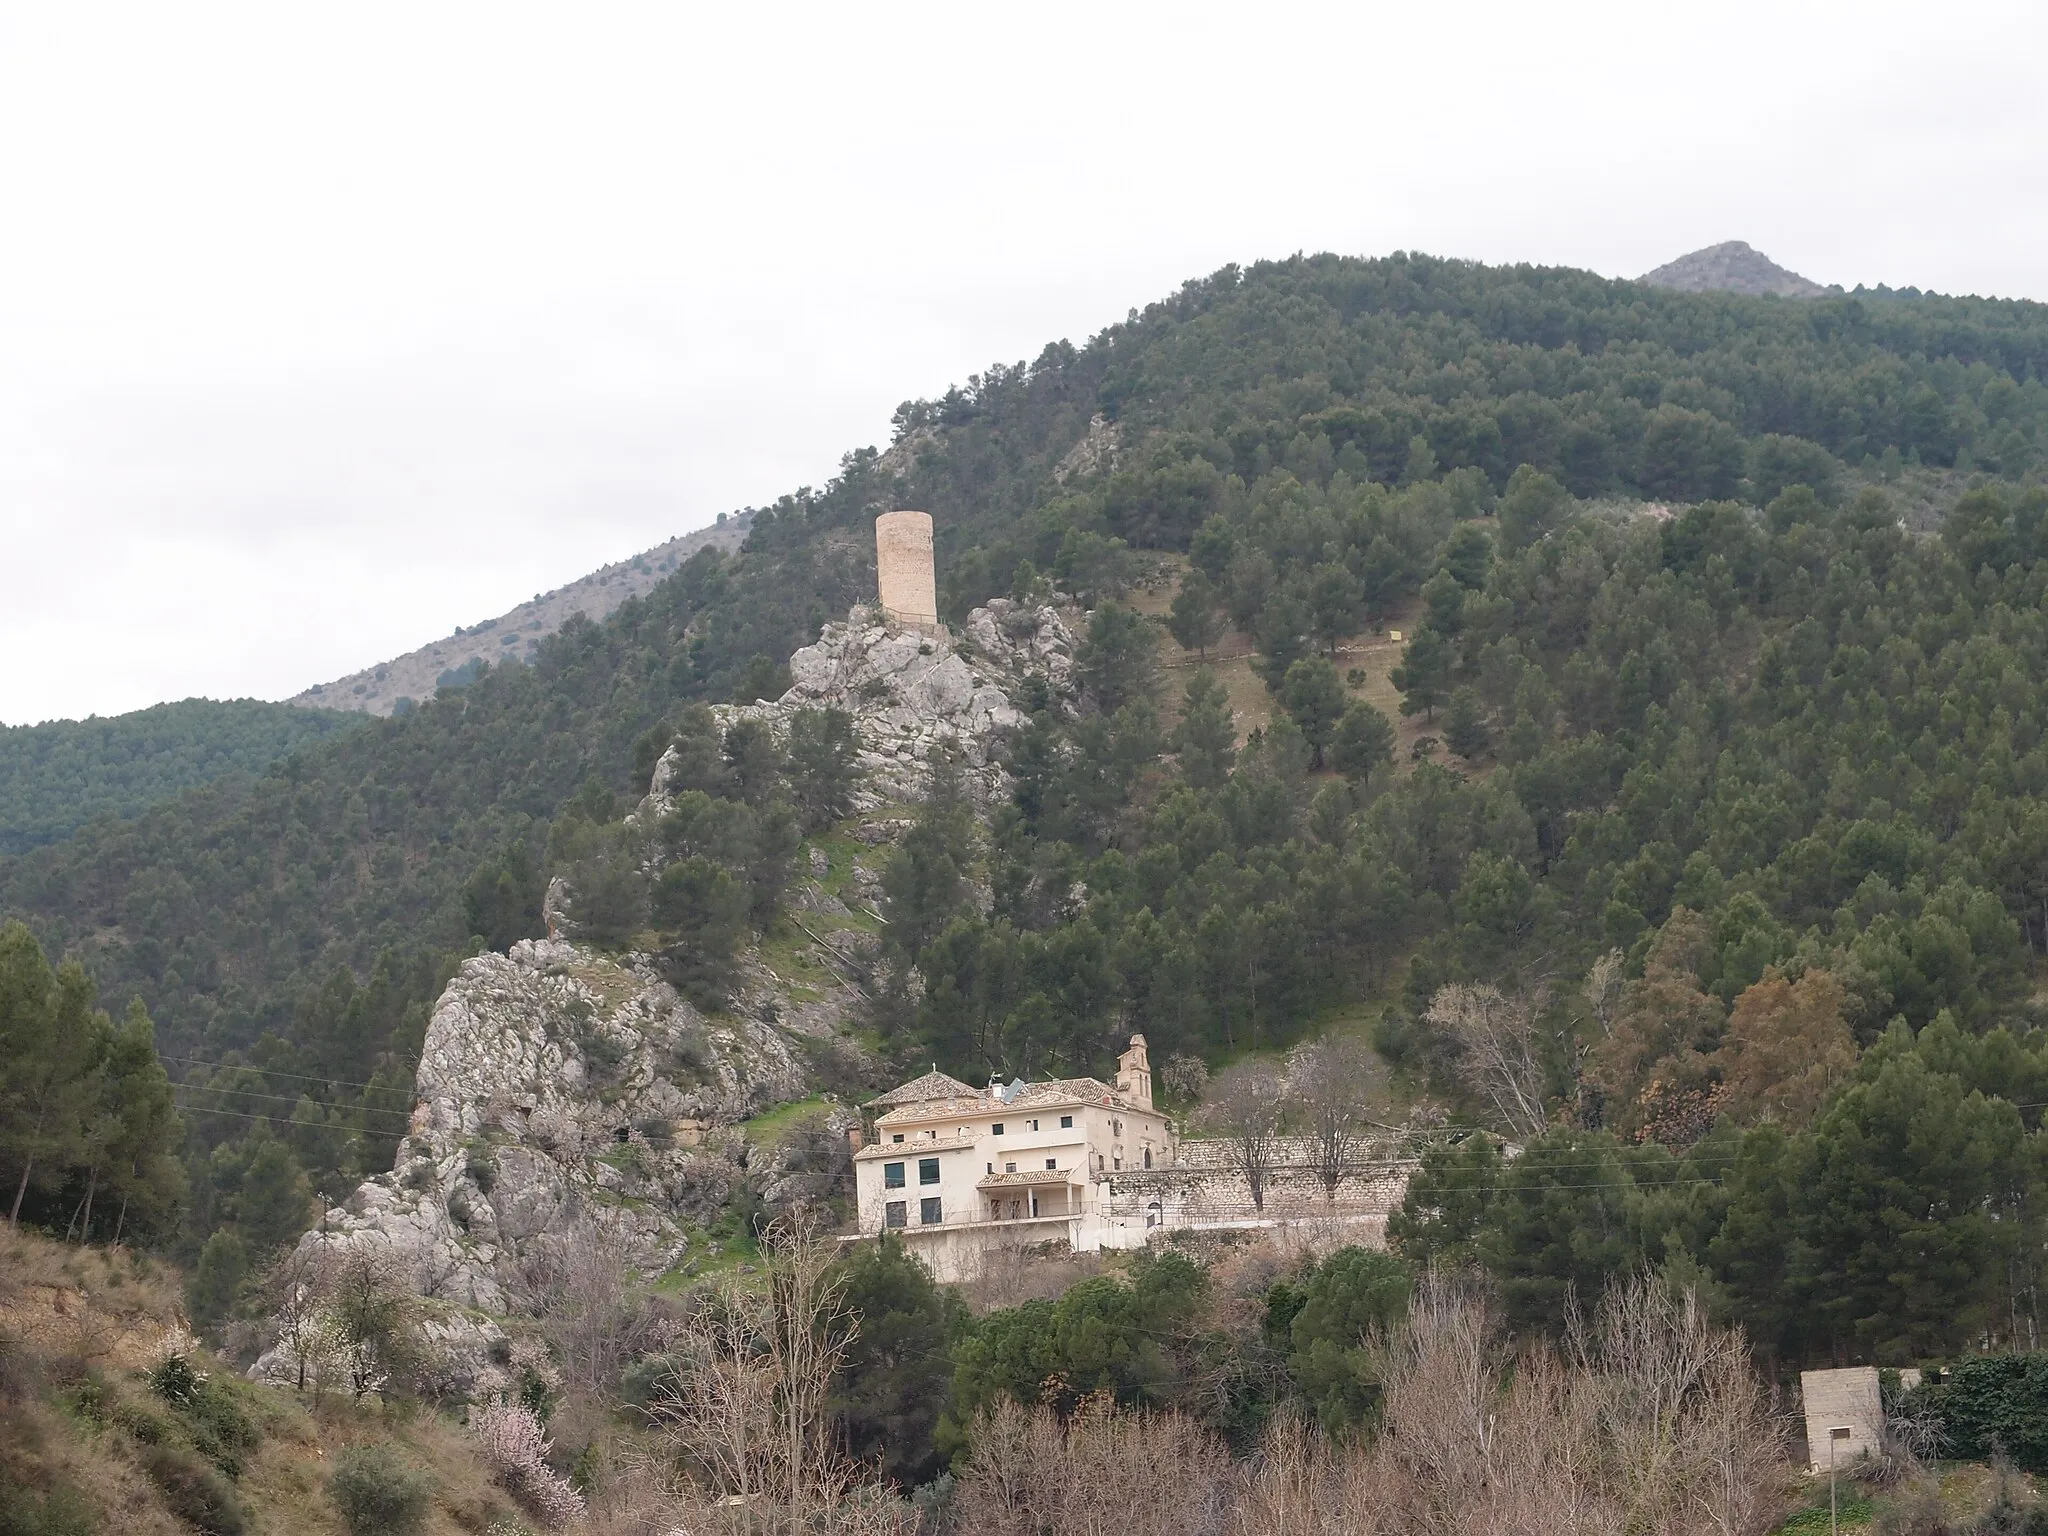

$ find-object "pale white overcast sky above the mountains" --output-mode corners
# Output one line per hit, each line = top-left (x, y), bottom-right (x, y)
(0, 0), (2048, 723)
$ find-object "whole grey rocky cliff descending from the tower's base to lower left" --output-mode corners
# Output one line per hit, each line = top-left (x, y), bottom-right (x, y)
(258, 602), (1073, 1374)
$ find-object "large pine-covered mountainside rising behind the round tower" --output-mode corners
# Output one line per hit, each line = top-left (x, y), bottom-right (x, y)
(0, 246), (2048, 1302)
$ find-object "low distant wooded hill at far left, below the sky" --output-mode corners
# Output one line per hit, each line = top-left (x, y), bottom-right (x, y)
(0, 698), (352, 854)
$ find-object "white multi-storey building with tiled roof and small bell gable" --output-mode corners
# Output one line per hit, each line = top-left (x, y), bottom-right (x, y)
(854, 1034), (1176, 1278)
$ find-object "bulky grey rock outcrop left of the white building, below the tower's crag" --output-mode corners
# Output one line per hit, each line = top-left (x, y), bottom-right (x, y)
(264, 940), (809, 1335)
